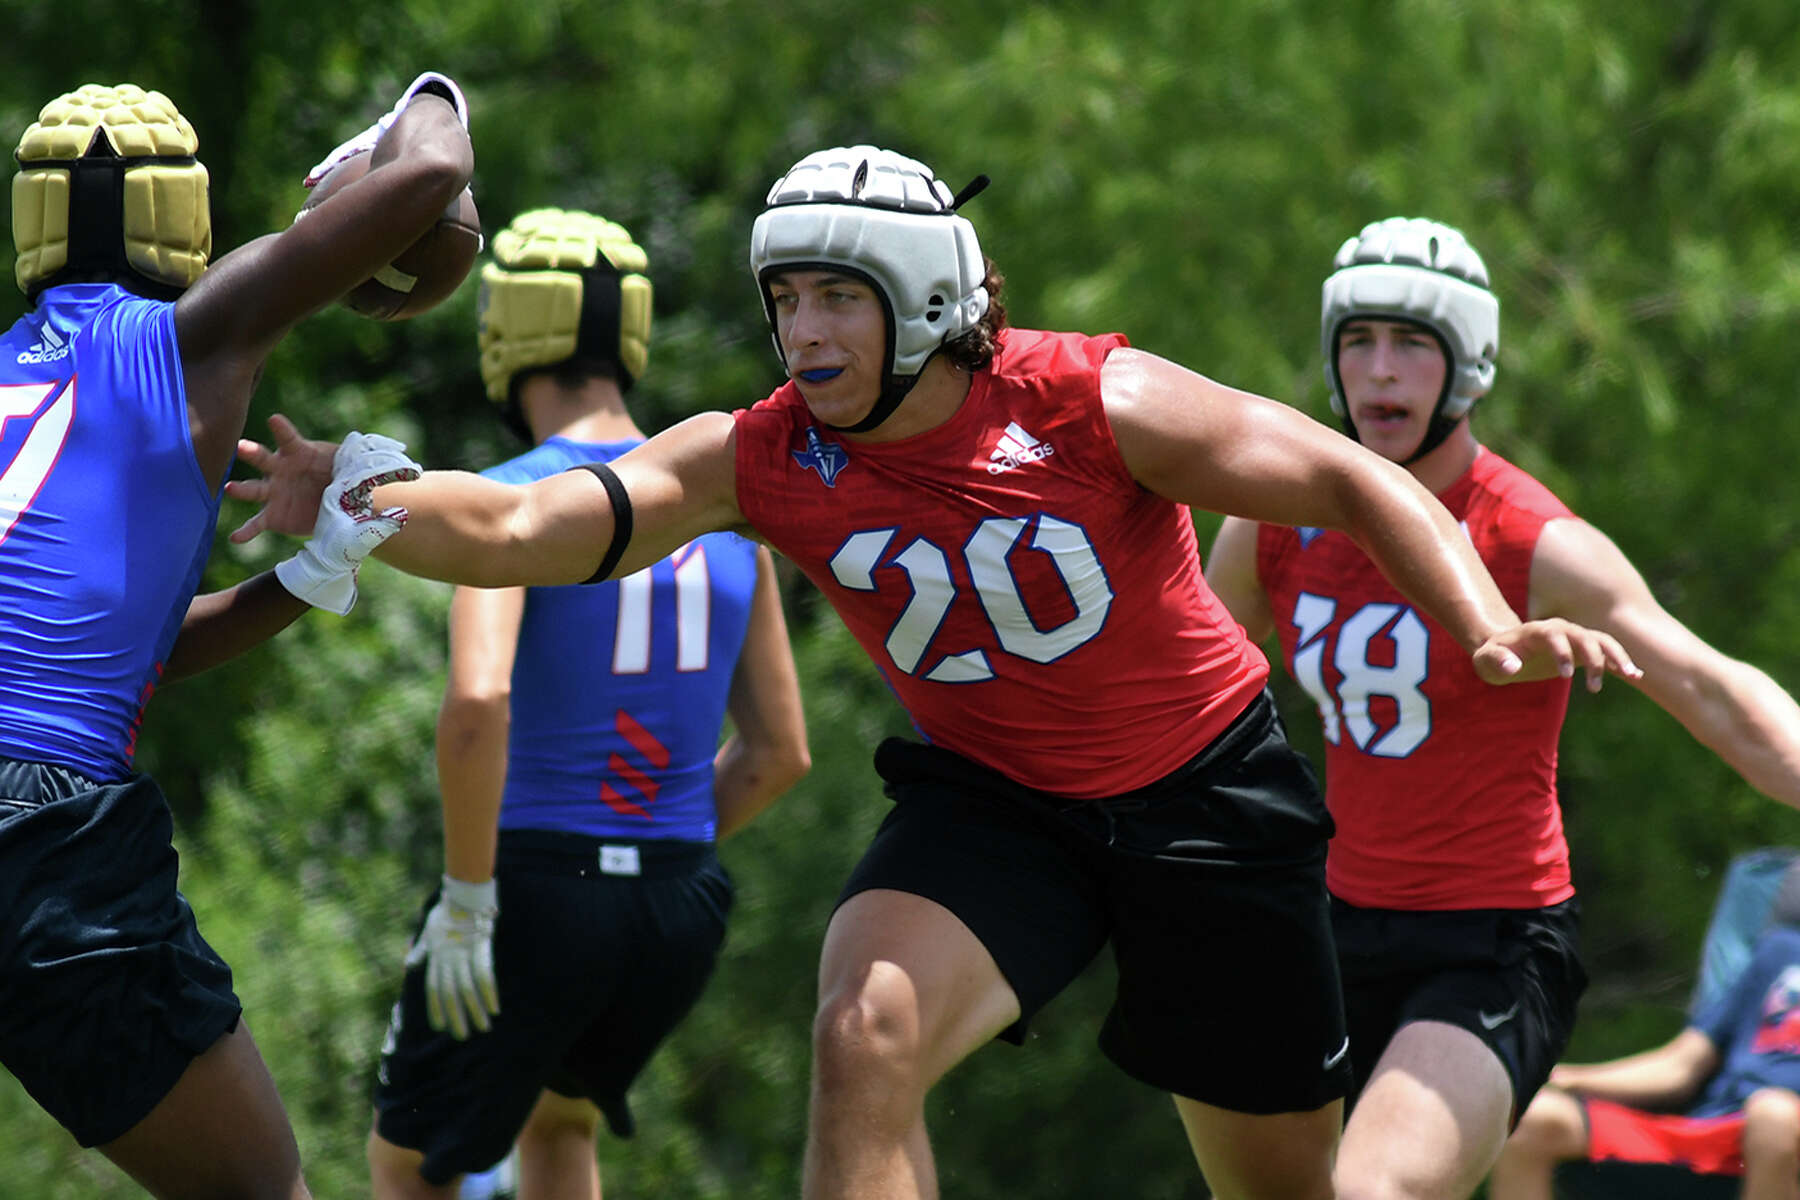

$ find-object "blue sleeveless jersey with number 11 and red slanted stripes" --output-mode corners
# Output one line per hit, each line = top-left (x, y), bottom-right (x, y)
(484, 437), (756, 842)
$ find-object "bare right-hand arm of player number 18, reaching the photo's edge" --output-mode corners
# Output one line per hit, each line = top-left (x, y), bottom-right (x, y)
(1532, 518), (1800, 808)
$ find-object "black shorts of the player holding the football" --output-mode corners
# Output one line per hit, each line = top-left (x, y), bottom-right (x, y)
(0, 757), (243, 1146)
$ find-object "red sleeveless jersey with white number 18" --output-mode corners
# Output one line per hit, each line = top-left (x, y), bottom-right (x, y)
(1256, 450), (1575, 909)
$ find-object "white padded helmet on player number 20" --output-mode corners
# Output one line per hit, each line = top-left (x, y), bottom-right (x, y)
(751, 146), (988, 376)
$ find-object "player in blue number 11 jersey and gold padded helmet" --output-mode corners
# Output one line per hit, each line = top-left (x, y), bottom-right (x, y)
(369, 209), (808, 1200)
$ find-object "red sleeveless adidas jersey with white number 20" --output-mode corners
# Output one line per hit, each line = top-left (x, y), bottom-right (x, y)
(736, 329), (1269, 799)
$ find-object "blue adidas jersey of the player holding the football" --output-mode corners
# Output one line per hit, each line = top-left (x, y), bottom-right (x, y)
(0, 284), (220, 783)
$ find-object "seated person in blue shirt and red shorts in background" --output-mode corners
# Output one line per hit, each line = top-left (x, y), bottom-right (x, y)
(1489, 865), (1800, 1200)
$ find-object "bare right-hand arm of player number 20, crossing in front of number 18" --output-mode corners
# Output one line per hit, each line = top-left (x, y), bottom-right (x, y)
(1100, 349), (1636, 689)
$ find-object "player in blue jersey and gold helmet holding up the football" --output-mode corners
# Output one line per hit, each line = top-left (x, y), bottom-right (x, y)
(0, 76), (472, 1196)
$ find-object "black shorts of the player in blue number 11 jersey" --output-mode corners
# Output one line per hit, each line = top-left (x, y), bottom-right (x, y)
(374, 829), (733, 1186)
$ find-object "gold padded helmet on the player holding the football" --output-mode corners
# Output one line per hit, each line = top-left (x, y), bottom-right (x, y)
(13, 83), (212, 300)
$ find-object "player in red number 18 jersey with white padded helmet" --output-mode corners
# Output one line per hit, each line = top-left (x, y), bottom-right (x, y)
(1206, 218), (1800, 1198)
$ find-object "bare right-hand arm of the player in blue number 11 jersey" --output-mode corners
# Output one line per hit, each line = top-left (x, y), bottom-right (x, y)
(713, 547), (812, 838)
